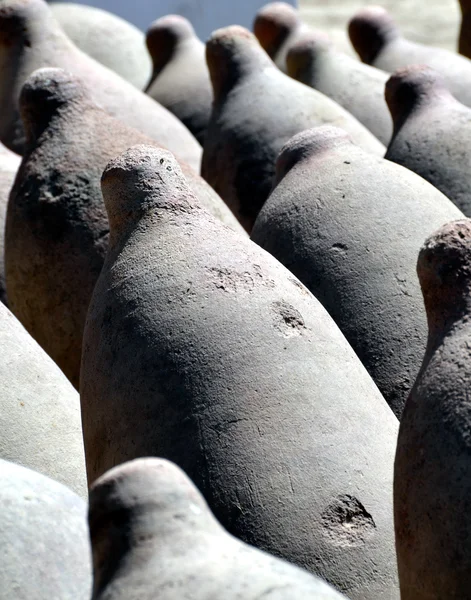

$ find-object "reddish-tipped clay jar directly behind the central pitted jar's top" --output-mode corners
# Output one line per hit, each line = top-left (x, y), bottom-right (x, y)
(202, 26), (384, 231)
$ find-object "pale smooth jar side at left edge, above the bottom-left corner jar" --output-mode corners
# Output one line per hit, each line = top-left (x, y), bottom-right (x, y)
(0, 304), (87, 500)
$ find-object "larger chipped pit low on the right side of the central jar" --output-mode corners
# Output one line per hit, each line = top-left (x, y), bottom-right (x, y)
(322, 494), (376, 547)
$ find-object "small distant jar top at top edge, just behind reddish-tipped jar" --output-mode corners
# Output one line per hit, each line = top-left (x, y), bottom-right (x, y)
(253, 2), (309, 73)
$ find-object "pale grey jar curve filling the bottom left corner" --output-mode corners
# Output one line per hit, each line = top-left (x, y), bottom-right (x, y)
(0, 458), (92, 600)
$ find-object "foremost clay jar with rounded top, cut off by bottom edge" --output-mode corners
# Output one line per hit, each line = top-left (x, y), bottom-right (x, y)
(89, 458), (345, 600)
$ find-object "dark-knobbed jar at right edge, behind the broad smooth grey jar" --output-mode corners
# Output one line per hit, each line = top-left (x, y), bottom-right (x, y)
(386, 66), (471, 216)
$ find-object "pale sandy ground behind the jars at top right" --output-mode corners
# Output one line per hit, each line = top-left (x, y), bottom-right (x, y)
(299, 0), (460, 53)
